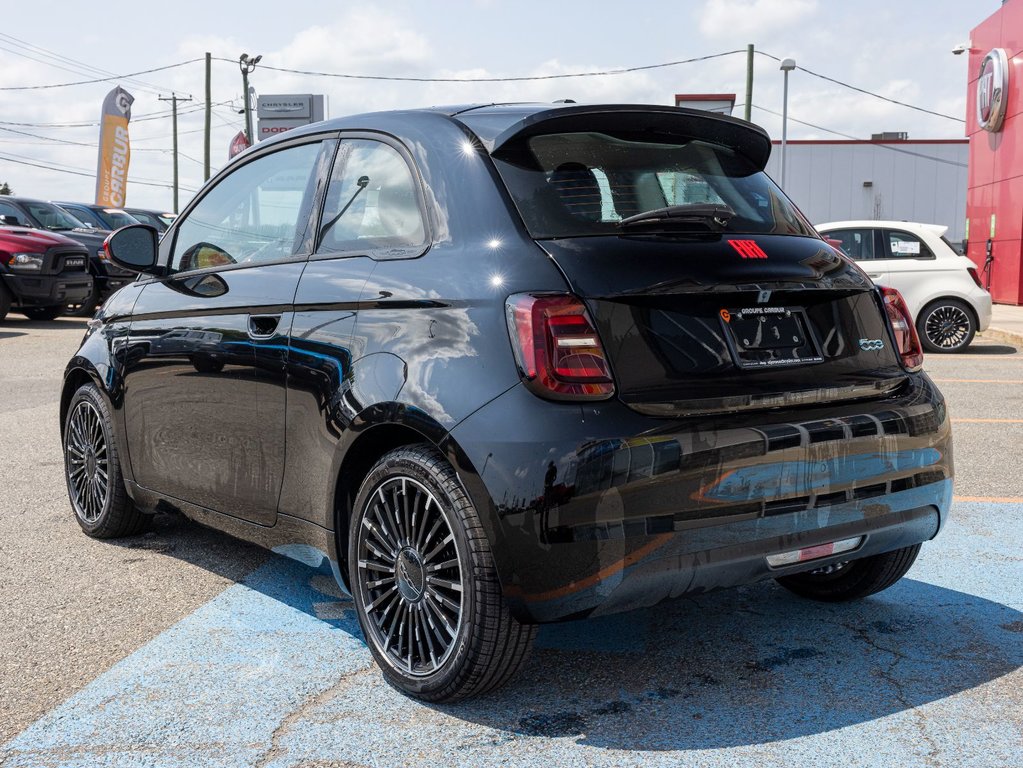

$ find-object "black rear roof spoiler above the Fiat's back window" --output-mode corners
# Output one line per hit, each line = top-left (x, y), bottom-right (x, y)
(478, 104), (771, 171)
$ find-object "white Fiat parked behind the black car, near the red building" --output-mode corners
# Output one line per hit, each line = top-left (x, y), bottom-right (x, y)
(817, 221), (991, 352)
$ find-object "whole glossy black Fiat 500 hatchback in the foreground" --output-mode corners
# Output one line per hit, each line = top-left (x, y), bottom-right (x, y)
(60, 104), (952, 701)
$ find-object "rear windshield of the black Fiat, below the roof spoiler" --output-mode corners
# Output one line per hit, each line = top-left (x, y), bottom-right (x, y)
(494, 132), (815, 239)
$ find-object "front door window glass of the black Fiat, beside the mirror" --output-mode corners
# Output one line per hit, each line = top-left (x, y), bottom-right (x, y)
(171, 142), (320, 272)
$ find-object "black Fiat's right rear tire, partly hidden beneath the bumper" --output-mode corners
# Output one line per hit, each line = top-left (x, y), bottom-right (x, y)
(776, 544), (921, 602)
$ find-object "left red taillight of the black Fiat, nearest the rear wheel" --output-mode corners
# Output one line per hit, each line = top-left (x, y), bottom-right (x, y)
(505, 293), (615, 400)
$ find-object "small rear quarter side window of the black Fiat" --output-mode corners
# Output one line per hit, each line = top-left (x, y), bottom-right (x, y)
(316, 139), (427, 254)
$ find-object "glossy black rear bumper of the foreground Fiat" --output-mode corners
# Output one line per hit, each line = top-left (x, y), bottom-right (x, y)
(451, 375), (952, 622)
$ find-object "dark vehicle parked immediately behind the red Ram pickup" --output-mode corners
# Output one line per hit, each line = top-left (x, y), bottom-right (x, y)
(0, 196), (135, 317)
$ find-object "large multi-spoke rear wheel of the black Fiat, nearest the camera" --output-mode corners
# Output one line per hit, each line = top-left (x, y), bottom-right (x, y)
(348, 444), (536, 702)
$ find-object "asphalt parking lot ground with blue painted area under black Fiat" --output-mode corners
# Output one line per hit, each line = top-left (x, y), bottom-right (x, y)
(0, 315), (1023, 768)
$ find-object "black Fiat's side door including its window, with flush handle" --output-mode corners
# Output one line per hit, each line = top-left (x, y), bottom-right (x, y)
(119, 136), (336, 525)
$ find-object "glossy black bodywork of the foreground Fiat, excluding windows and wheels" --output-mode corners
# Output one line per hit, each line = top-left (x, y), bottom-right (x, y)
(61, 105), (952, 622)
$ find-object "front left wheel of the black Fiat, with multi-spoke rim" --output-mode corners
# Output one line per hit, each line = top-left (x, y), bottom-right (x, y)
(63, 383), (148, 539)
